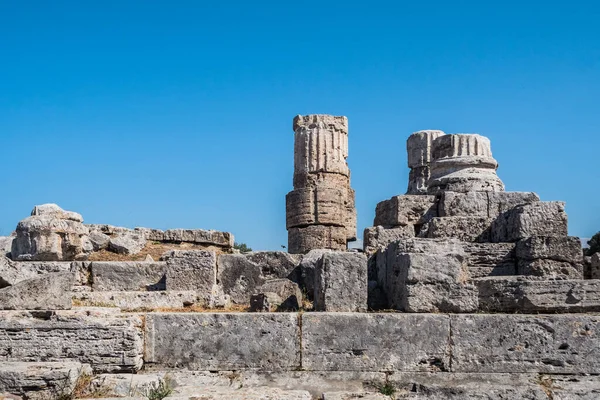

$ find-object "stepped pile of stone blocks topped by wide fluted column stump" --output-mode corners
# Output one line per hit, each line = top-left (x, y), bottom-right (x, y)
(364, 133), (584, 312)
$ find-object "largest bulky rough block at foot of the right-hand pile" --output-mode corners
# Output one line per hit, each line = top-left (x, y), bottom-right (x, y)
(377, 241), (477, 312)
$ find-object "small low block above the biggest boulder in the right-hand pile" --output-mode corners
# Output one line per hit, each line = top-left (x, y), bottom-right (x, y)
(419, 217), (493, 242)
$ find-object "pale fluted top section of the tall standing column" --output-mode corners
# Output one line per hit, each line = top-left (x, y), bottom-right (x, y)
(294, 115), (350, 176)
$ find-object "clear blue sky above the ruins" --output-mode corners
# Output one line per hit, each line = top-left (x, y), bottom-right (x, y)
(0, 0), (600, 249)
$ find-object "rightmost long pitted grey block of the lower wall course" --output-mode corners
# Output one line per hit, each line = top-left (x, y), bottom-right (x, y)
(450, 314), (600, 374)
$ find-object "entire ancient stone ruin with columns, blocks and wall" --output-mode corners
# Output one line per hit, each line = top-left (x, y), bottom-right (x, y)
(0, 115), (600, 400)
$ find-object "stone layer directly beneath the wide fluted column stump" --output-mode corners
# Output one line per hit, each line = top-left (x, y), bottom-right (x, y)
(438, 191), (540, 218)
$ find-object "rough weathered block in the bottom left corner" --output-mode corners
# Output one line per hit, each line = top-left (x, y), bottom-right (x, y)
(0, 362), (89, 400)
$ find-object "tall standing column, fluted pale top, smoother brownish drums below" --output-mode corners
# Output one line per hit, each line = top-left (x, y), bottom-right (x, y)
(286, 115), (356, 254)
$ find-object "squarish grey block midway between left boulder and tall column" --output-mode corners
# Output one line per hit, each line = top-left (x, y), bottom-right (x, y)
(163, 250), (217, 295)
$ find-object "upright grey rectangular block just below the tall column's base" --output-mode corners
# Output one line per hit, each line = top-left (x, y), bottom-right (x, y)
(314, 253), (368, 312)
